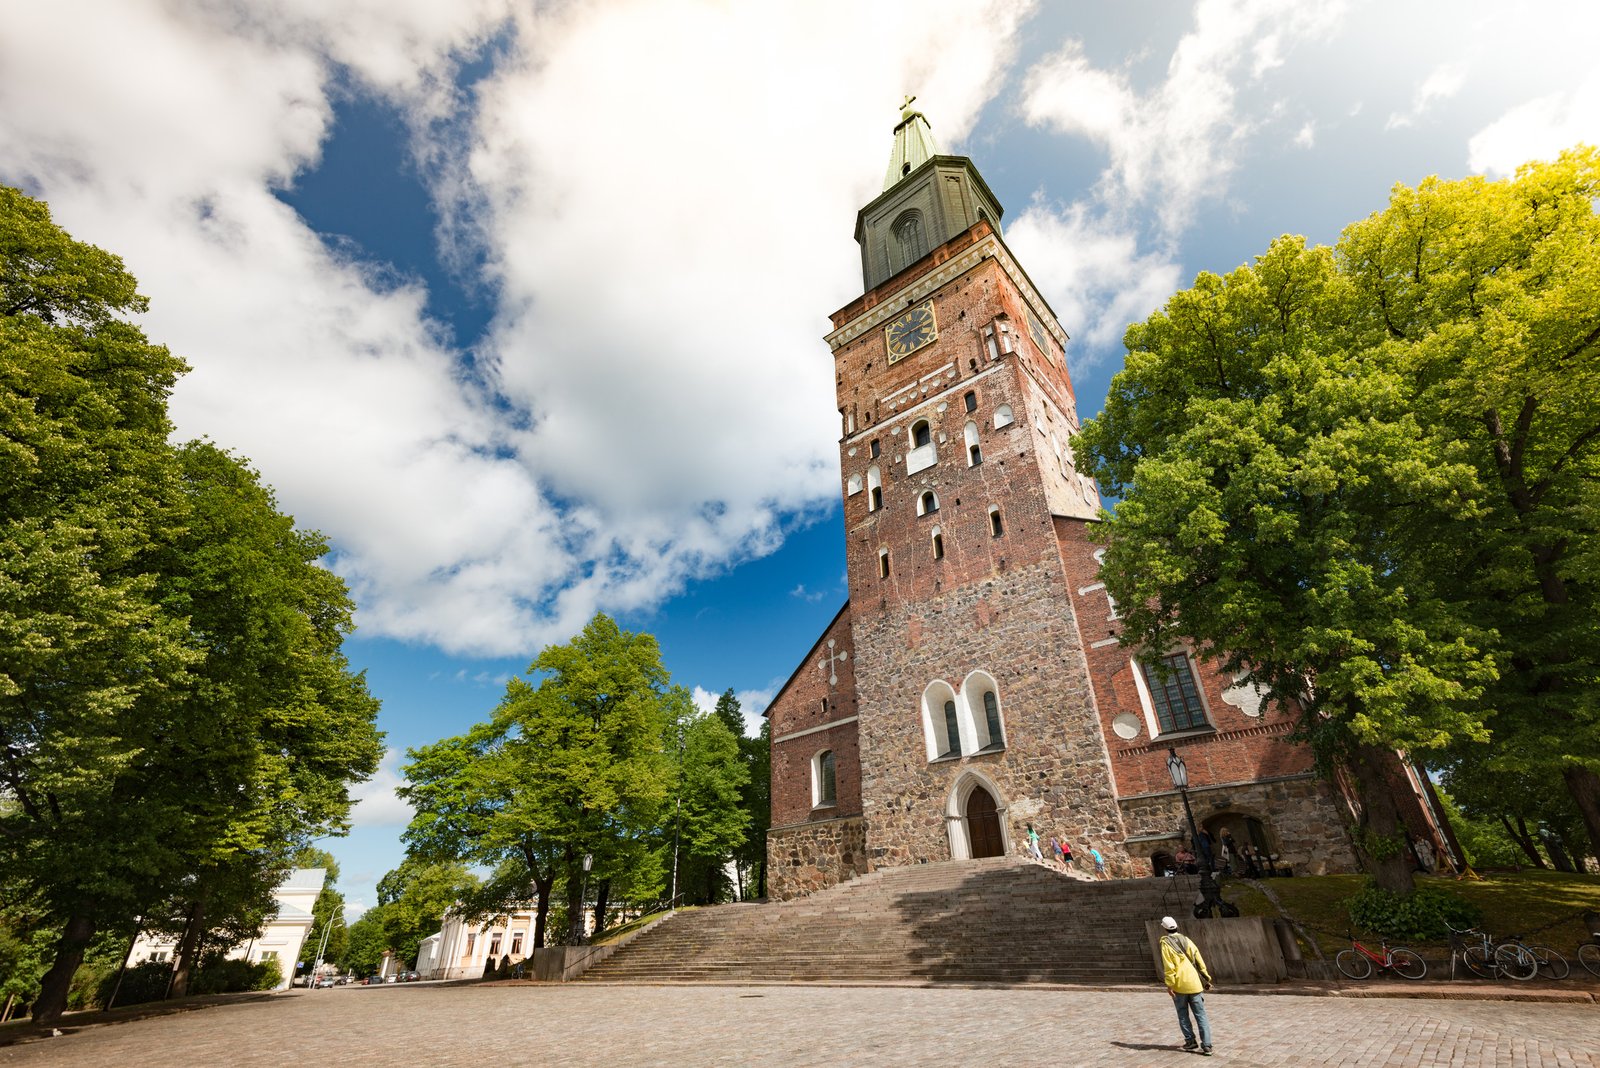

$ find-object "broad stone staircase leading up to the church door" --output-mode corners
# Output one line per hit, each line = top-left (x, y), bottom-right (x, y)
(582, 857), (1194, 985)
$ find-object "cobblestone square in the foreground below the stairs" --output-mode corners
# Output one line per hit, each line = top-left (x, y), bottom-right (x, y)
(0, 983), (1600, 1068)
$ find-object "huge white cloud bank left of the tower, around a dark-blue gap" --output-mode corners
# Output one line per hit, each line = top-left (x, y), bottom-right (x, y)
(0, 0), (1030, 654)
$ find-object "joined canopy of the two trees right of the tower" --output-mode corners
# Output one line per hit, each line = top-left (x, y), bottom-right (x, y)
(1077, 150), (1600, 886)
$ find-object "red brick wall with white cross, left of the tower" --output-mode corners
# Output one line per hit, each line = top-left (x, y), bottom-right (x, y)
(766, 604), (861, 827)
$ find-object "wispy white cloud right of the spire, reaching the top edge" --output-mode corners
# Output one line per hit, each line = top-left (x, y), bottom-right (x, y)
(1022, 0), (1344, 237)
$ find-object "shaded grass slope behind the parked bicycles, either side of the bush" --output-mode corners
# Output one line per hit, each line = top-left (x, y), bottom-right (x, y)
(1224, 870), (1600, 958)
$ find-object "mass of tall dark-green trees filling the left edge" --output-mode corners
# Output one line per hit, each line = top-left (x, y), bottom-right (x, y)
(0, 189), (381, 1022)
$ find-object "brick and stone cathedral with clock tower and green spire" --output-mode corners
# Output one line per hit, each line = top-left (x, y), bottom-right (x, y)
(766, 102), (1452, 899)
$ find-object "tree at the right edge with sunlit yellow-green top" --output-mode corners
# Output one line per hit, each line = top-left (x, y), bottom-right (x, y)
(1339, 149), (1600, 857)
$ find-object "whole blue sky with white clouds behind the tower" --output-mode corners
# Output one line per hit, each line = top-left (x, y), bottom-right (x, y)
(0, 0), (1600, 905)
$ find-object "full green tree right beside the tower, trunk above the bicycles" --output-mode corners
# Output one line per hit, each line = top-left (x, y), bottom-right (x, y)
(1077, 231), (1494, 892)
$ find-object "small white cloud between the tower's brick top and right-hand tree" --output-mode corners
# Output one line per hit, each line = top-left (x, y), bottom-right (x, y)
(1006, 203), (1181, 362)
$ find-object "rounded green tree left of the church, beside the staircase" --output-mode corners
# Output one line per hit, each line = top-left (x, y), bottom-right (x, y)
(400, 616), (674, 946)
